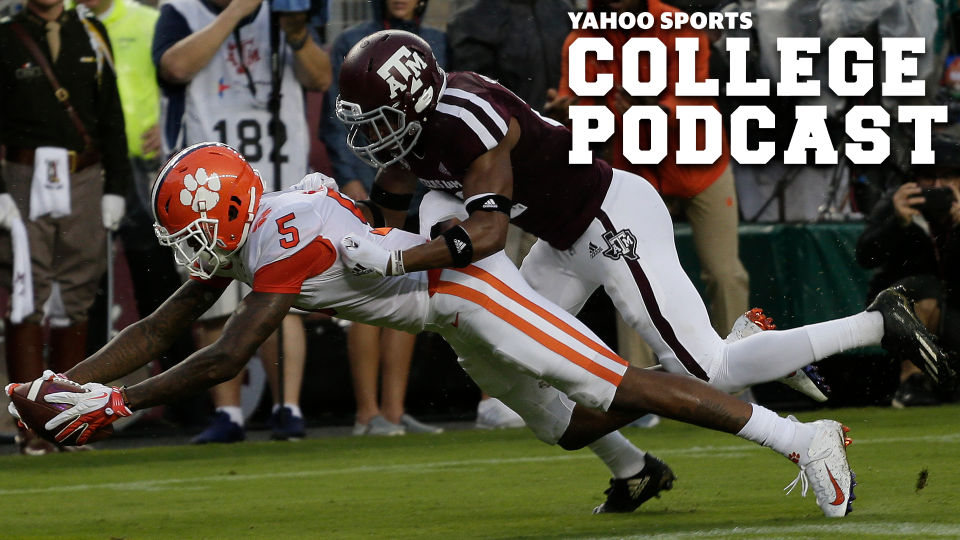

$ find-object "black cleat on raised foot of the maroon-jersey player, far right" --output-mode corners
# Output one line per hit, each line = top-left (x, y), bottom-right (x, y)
(867, 285), (957, 393)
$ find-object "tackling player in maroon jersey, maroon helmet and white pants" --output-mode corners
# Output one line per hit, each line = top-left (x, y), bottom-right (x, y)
(337, 30), (954, 511)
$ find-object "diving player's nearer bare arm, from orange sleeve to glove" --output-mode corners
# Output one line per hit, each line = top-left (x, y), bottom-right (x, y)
(126, 291), (297, 410)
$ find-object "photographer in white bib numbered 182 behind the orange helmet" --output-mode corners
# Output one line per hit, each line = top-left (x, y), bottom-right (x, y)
(153, 0), (331, 443)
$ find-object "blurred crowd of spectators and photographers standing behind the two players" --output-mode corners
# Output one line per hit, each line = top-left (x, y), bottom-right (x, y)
(0, 0), (960, 454)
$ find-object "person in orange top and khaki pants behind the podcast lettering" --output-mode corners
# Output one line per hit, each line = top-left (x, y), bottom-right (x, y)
(548, 0), (750, 362)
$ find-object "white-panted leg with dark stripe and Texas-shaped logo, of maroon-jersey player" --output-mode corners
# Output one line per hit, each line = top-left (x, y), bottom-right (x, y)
(565, 171), (932, 392)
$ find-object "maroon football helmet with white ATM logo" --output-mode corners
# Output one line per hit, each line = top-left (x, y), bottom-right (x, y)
(337, 30), (446, 167)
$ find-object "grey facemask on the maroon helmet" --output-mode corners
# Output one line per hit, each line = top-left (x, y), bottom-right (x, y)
(337, 97), (422, 168)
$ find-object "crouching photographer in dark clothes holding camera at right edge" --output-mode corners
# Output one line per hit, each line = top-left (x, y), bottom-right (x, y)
(857, 132), (960, 408)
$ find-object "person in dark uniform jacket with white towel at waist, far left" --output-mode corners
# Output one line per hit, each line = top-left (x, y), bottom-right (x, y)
(0, 0), (131, 454)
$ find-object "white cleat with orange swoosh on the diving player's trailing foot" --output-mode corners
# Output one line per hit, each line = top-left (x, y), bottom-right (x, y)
(783, 416), (857, 517)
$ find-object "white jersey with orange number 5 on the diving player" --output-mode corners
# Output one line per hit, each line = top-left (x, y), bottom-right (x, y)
(202, 188), (430, 333)
